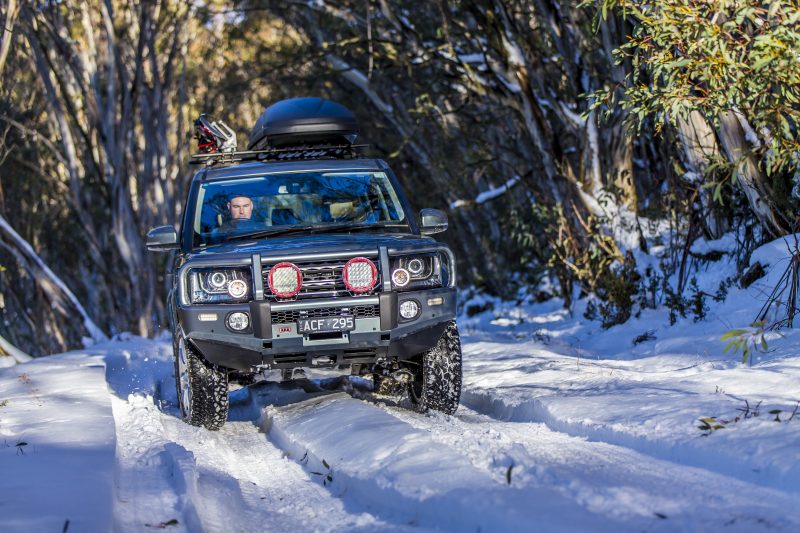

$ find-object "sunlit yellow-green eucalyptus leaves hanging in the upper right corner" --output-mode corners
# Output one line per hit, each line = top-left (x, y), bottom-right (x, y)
(603, 0), (800, 166)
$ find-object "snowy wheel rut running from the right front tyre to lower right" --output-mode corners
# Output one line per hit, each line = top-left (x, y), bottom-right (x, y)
(378, 406), (800, 532)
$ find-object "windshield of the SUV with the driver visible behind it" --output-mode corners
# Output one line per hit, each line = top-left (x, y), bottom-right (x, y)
(193, 171), (405, 245)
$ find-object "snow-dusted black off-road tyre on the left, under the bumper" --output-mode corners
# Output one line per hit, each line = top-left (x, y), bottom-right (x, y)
(173, 336), (228, 431)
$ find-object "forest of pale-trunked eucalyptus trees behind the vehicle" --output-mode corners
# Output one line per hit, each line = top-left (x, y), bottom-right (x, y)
(0, 0), (800, 355)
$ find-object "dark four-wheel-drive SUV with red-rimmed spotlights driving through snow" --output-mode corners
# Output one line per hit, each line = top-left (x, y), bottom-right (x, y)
(147, 98), (461, 429)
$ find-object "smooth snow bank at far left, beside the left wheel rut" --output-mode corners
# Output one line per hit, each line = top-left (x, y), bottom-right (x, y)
(0, 354), (115, 531)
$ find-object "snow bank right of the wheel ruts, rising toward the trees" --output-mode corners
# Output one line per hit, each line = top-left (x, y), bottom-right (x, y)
(459, 237), (800, 493)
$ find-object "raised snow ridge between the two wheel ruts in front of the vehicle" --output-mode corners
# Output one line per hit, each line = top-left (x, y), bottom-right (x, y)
(264, 386), (612, 531)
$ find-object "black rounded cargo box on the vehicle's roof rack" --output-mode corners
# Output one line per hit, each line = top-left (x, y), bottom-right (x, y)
(247, 98), (358, 150)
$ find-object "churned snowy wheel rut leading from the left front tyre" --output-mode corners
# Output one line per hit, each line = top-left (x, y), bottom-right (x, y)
(106, 342), (398, 533)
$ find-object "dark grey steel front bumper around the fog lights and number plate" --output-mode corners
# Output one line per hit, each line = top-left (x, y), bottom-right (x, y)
(178, 288), (456, 372)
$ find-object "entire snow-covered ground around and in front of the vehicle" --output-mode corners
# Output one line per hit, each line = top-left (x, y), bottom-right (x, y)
(0, 238), (800, 532)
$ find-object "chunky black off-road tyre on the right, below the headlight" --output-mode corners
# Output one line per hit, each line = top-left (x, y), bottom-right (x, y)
(409, 322), (461, 415)
